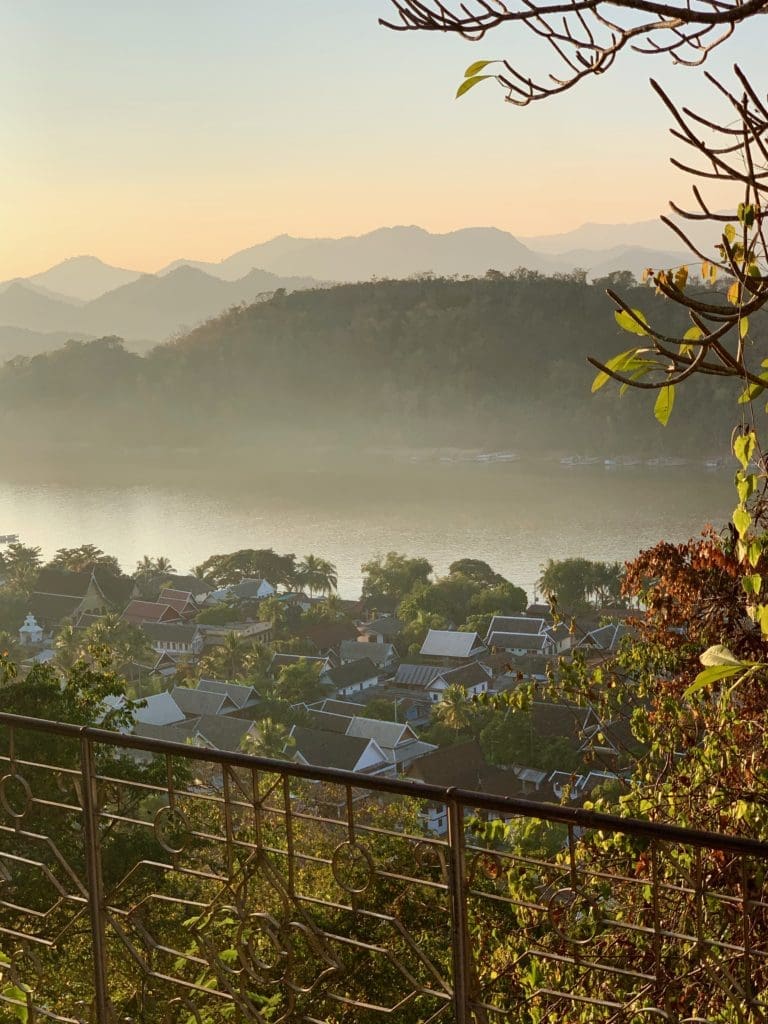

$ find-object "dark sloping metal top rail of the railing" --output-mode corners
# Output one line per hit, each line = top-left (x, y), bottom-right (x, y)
(0, 713), (768, 859)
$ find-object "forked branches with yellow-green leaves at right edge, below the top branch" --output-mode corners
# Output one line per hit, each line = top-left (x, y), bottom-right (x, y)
(590, 68), (768, 424)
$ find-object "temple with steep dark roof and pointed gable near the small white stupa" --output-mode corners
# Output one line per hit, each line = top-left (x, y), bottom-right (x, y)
(29, 567), (135, 630)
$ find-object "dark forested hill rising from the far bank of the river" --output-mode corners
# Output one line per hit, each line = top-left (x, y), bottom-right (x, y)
(0, 271), (736, 456)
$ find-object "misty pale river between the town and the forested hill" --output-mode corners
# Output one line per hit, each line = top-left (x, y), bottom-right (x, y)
(0, 455), (735, 597)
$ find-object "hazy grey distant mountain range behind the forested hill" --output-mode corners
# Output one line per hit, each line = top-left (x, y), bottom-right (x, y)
(0, 221), (711, 358)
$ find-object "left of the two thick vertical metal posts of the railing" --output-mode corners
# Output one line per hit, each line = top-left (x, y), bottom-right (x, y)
(80, 734), (111, 1024)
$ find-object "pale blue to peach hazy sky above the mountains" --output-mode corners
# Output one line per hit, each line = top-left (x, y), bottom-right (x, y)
(0, 0), (765, 278)
